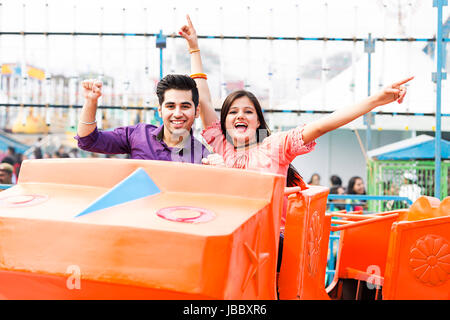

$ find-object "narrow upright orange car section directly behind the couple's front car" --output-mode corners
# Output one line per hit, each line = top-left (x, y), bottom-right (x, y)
(278, 186), (331, 300)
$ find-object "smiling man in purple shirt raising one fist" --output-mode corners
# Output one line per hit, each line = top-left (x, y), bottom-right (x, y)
(75, 75), (209, 164)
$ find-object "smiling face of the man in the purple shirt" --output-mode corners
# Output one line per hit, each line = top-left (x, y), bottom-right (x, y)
(158, 89), (198, 136)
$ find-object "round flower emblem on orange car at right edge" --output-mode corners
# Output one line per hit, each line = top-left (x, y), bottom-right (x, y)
(409, 234), (450, 286)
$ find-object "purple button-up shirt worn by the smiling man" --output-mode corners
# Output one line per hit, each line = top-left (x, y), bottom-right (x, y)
(75, 123), (209, 164)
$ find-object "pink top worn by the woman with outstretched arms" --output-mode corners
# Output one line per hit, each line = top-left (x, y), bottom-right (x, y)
(202, 121), (316, 230)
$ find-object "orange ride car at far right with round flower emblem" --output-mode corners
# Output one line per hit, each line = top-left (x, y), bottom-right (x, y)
(383, 196), (450, 300)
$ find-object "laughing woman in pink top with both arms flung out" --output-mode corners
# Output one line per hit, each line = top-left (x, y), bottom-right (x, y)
(179, 16), (413, 185)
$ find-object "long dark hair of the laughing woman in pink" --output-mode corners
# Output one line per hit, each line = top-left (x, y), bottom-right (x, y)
(220, 90), (303, 187)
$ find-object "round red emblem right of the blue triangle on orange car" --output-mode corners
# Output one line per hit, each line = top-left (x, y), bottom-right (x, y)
(156, 206), (216, 223)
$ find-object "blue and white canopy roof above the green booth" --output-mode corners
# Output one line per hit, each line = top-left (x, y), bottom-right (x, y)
(367, 134), (450, 160)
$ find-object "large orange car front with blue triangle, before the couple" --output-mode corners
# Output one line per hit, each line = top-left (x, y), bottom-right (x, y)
(0, 159), (285, 299)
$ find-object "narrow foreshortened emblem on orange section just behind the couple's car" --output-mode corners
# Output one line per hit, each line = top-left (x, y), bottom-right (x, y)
(307, 211), (322, 276)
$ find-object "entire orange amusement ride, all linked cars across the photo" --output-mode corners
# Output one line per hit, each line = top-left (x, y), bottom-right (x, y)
(0, 159), (450, 300)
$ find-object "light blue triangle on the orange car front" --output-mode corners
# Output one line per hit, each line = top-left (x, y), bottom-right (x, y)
(75, 168), (161, 217)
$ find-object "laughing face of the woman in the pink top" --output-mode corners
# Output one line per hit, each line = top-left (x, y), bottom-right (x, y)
(225, 96), (260, 146)
